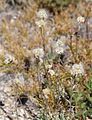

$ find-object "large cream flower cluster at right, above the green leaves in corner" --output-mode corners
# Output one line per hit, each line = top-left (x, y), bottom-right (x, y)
(70, 62), (85, 76)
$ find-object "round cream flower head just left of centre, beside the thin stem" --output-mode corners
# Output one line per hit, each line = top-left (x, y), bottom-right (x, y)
(32, 48), (44, 59)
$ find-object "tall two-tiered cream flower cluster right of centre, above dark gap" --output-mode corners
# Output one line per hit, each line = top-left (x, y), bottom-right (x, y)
(53, 37), (66, 54)
